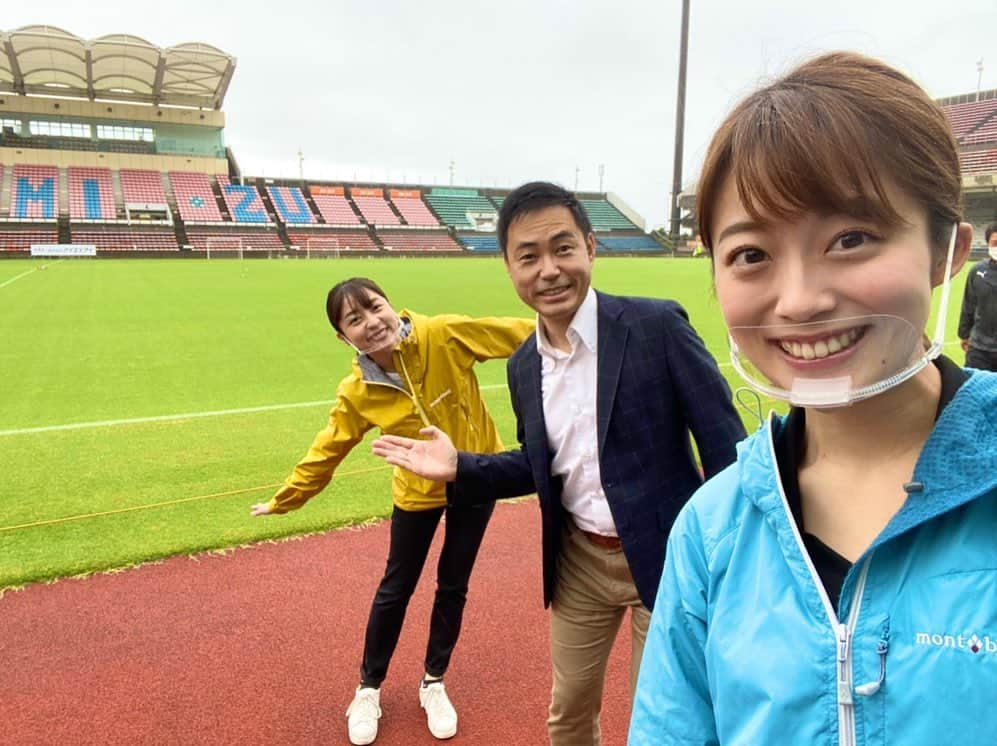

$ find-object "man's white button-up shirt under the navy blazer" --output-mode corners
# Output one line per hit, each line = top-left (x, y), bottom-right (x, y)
(536, 288), (617, 536)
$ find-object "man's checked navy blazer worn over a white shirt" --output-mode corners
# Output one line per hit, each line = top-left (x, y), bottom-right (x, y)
(447, 292), (745, 609)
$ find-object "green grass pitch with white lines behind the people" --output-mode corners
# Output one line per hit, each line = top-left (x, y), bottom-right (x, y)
(0, 257), (965, 590)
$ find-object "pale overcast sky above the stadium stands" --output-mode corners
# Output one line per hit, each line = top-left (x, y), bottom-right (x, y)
(0, 0), (997, 228)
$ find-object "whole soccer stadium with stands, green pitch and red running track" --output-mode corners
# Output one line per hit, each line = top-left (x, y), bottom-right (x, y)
(0, 21), (997, 744)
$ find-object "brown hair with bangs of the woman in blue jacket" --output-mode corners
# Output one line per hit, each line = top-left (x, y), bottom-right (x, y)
(696, 52), (962, 254)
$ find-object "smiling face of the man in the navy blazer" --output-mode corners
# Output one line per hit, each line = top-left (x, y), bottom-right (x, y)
(505, 205), (595, 333)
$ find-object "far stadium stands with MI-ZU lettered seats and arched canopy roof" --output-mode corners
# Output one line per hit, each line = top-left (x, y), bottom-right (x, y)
(0, 26), (662, 258)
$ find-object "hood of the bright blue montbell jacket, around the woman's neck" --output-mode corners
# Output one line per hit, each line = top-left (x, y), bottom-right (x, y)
(737, 371), (997, 549)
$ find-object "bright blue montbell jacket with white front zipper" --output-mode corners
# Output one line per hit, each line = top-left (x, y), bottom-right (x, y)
(629, 372), (997, 746)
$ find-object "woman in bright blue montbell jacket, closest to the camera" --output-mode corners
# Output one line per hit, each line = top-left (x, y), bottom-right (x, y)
(630, 53), (997, 746)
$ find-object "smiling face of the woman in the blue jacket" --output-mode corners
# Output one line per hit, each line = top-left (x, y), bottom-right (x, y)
(711, 179), (944, 390)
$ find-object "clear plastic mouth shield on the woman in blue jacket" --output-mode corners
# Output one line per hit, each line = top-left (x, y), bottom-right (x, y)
(728, 224), (959, 407)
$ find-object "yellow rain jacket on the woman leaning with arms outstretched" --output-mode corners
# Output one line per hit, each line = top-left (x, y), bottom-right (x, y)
(270, 311), (535, 513)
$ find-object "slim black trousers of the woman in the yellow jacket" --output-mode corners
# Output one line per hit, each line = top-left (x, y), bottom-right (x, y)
(360, 503), (495, 687)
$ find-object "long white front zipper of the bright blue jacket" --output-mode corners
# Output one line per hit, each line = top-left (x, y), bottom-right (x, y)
(768, 417), (872, 746)
